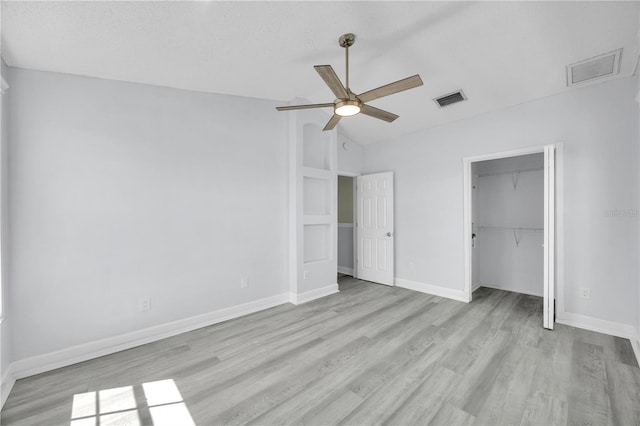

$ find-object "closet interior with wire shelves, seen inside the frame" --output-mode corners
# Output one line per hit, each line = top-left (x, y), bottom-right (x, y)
(472, 153), (544, 297)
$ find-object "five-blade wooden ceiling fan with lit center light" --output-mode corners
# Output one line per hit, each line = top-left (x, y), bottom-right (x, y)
(276, 33), (422, 130)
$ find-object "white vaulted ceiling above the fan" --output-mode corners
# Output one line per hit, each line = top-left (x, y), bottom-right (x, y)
(2, 1), (640, 144)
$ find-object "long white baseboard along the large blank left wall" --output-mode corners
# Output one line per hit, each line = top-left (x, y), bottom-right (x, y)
(11, 293), (289, 379)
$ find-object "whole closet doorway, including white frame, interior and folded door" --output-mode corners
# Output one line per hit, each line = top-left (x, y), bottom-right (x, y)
(463, 145), (556, 329)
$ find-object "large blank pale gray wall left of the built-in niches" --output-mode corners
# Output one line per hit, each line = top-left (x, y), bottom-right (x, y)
(9, 69), (287, 359)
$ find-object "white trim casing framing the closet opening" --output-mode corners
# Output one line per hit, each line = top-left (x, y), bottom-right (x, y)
(462, 143), (564, 330)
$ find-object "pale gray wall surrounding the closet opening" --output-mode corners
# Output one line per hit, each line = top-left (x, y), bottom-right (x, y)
(363, 78), (639, 325)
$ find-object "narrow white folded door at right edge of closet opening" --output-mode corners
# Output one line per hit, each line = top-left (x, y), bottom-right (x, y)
(542, 146), (556, 330)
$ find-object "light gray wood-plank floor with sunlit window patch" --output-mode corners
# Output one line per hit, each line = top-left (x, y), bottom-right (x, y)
(2, 278), (640, 426)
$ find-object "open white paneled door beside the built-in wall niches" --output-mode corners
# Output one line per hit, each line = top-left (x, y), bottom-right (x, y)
(356, 172), (394, 285)
